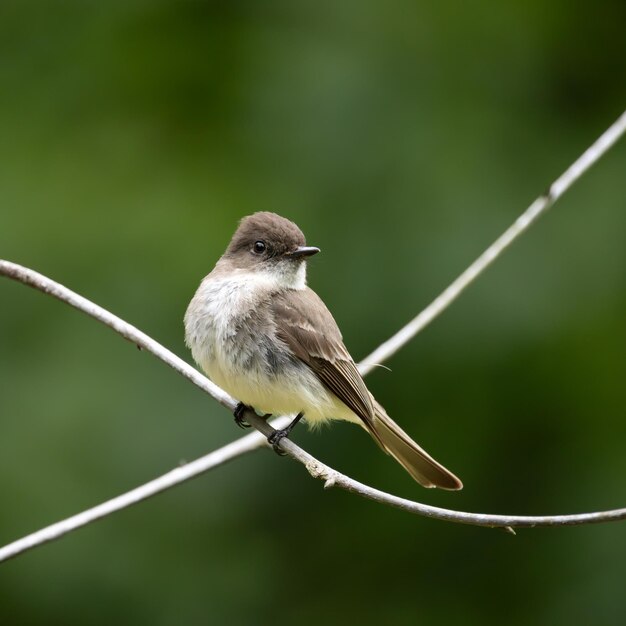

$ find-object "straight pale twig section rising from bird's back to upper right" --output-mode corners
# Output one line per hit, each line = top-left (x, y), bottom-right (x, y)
(360, 112), (626, 374)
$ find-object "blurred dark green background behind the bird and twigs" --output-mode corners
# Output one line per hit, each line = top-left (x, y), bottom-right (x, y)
(0, 0), (626, 625)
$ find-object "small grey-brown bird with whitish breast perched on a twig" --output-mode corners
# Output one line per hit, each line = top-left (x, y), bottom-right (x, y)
(185, 212), (463, 490)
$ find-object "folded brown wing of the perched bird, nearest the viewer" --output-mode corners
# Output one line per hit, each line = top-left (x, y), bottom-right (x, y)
(271, 288), (374, 431)
